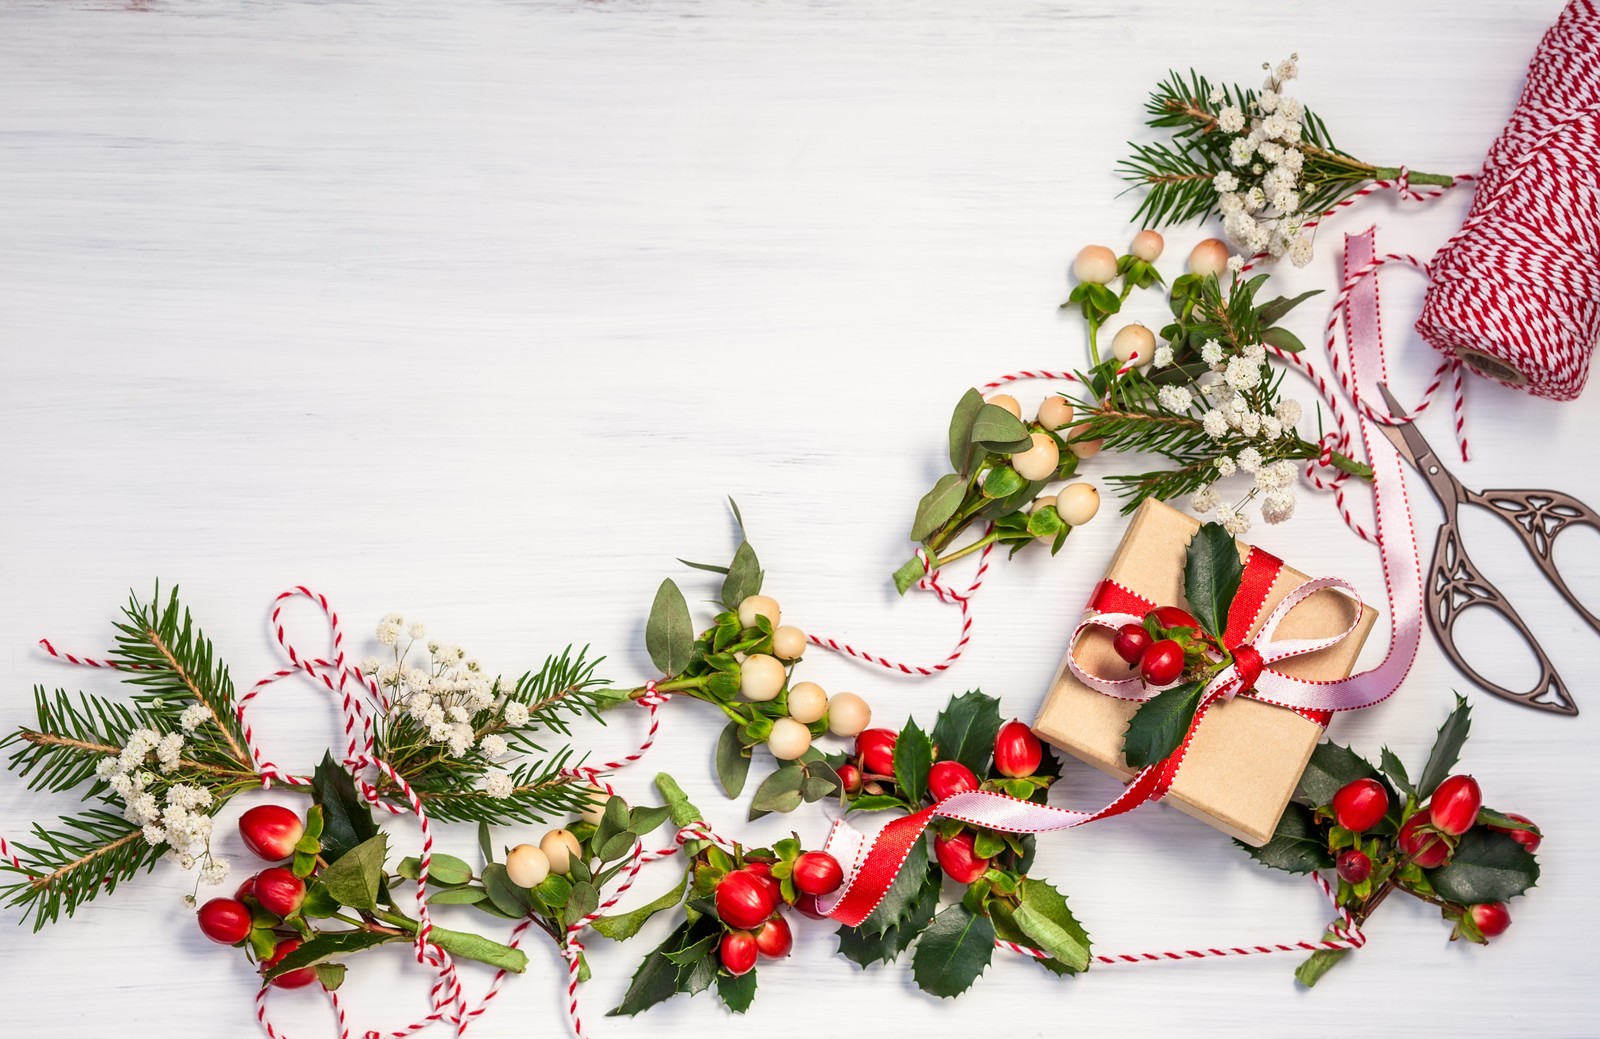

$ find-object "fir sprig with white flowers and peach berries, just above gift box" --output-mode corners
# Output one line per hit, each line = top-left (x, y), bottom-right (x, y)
(1070, 232), (1371, 535)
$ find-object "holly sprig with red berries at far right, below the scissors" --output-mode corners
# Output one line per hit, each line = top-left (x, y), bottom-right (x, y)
(1240, 696), (1542, 986)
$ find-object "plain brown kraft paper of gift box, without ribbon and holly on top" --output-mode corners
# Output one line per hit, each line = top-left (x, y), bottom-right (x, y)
(1034, 499), (1378, 845)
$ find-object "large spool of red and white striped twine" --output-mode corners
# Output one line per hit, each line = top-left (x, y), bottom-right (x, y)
(1416, 0), (1600, 400)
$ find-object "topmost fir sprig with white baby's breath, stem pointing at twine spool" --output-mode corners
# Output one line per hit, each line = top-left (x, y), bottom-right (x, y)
(1118, 54), (1454, 267)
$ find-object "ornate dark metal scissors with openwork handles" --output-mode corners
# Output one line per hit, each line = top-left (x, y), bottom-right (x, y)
(1378, 383), (1600, 714)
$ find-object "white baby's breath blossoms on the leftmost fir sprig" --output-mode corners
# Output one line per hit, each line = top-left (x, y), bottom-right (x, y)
(94, 726), (227, 884)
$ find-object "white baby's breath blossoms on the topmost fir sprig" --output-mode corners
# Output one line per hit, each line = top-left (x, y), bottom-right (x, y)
(1210, 54), (1312, 267)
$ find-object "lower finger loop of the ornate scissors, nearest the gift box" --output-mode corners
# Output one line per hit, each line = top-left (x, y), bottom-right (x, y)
(1427, 524), (1578, 714)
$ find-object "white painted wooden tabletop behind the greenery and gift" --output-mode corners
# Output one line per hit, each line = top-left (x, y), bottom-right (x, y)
(0, 0), (1600, 1037)
